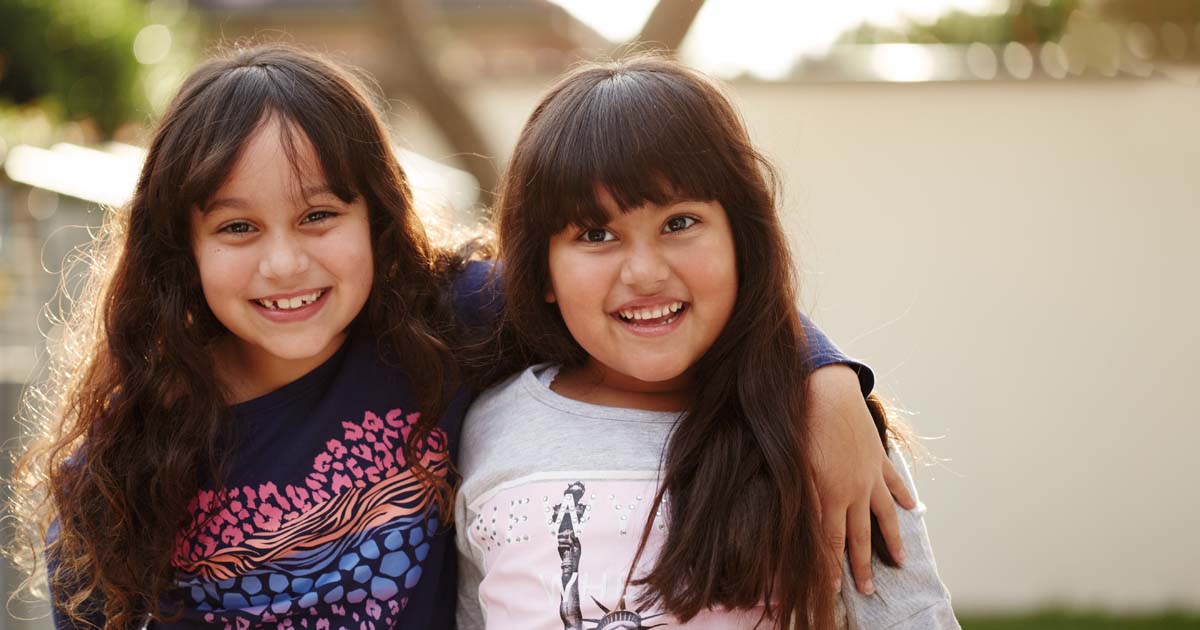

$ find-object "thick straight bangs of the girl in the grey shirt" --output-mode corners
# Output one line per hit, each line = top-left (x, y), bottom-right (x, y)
(526, 65), (739, 233)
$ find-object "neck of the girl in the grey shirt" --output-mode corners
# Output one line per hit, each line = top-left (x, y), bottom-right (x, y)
(550, 359), (691, 412)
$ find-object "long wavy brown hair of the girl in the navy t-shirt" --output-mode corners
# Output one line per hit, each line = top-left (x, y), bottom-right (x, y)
(11, 44), (457, 628)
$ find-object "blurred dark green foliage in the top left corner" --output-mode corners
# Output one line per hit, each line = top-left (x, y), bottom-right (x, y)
(0, 0), (145, 133)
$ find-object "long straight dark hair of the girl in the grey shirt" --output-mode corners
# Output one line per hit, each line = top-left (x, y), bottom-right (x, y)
(496, 55), (897, 628)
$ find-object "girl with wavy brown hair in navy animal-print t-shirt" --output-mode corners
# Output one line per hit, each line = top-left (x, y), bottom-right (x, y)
(14, 46), (902, 629)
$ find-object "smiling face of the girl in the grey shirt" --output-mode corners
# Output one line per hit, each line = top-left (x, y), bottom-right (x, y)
(546, 191), (738, 391)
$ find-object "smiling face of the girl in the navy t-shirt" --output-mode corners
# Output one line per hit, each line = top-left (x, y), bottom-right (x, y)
(192, 116), (373, 394)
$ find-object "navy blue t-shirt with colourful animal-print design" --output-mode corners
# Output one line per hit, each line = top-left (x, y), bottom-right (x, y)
(50, 264), (872, 630)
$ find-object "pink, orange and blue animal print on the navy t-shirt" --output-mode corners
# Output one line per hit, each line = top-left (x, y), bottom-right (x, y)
(174, 409), (449, 628)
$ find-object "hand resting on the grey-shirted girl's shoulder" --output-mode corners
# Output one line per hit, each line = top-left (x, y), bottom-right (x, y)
(805, 365), (917, 595)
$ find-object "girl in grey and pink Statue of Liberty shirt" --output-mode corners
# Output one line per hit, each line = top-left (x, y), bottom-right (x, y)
(456, 58), (958, 630)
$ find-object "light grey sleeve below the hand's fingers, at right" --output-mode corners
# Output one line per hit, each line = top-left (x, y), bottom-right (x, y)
(841, 448), (961, 630)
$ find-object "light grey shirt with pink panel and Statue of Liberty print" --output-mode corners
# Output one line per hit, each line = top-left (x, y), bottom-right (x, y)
(455, 366), (959, 630)
